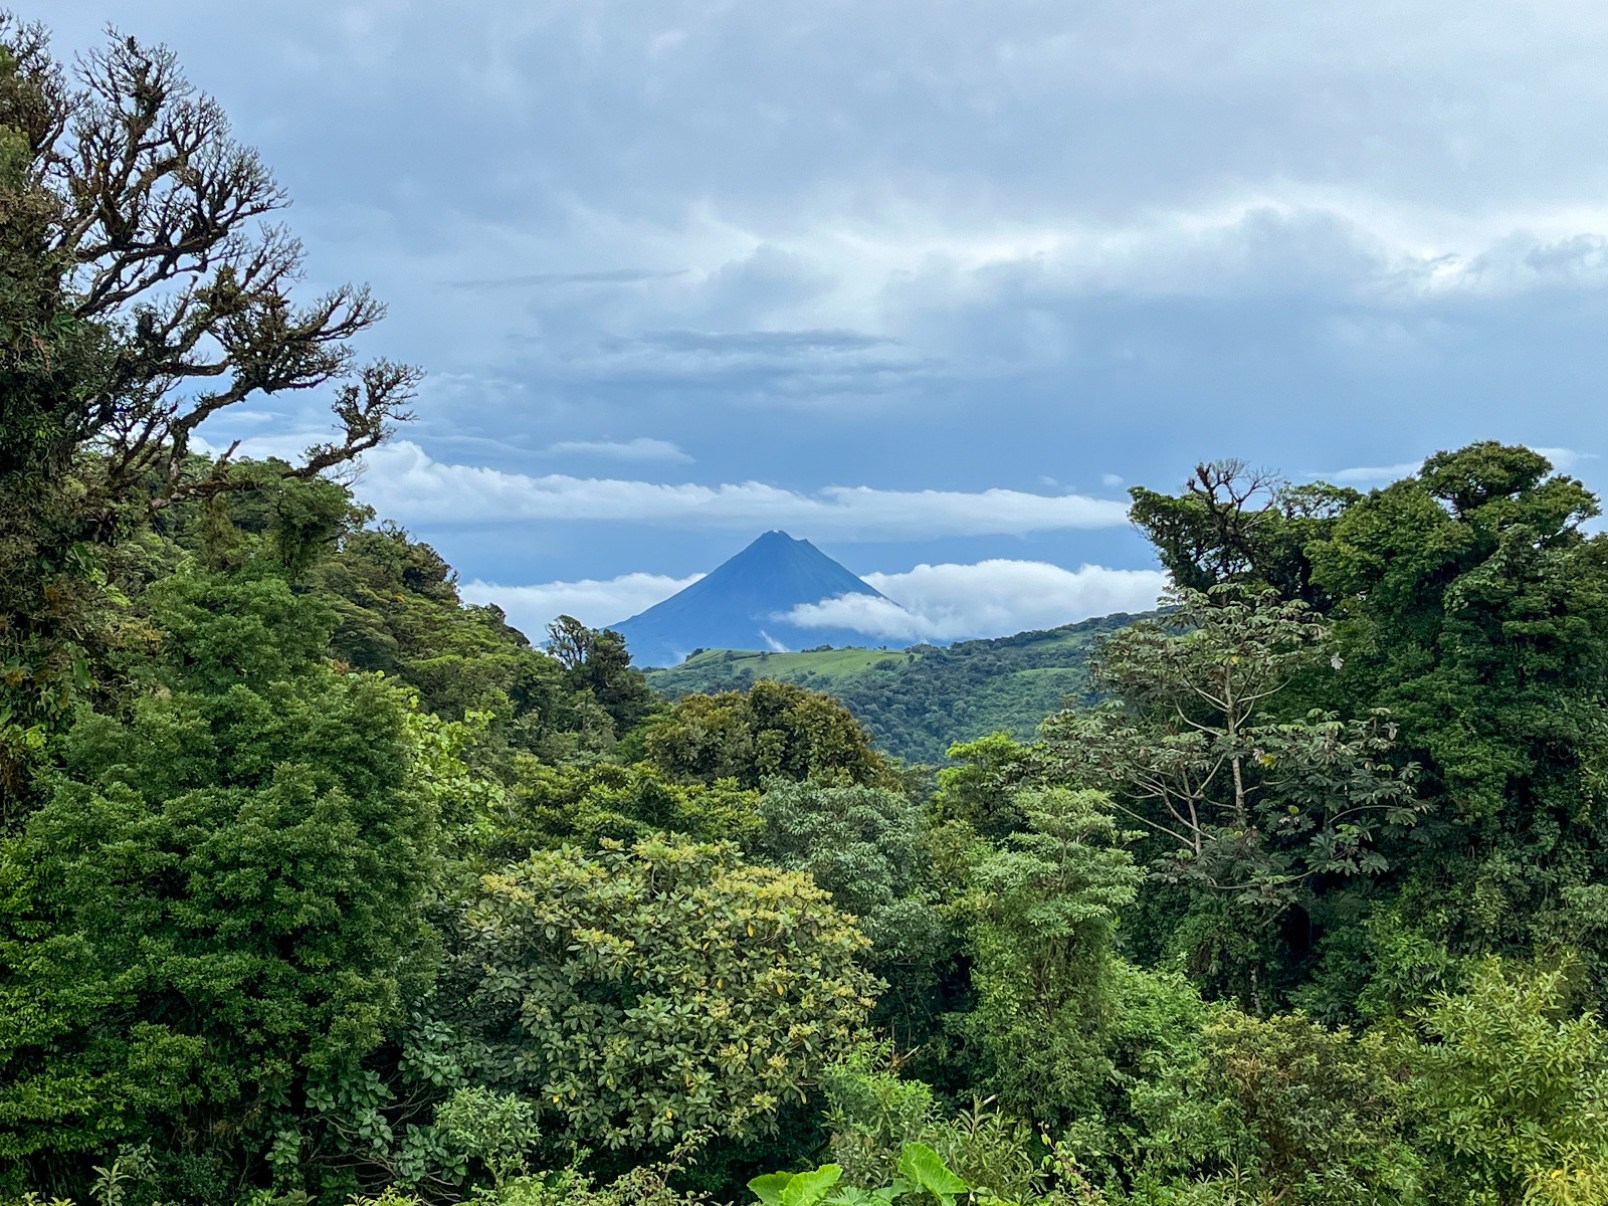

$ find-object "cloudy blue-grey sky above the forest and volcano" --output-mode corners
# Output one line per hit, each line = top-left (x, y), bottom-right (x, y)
(44, 0), (1608, 640)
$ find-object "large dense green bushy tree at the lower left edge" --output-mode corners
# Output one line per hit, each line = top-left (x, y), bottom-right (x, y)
(0, 571), (437, 1196)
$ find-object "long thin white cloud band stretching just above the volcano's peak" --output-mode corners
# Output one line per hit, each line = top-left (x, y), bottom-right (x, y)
(336, 441), (1127, 540)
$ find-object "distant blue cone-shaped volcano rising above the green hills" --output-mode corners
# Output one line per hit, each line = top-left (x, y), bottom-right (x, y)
(609, 532), (900, 666)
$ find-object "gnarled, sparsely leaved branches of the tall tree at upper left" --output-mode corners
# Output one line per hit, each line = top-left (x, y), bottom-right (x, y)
(0, 13), (416, 518)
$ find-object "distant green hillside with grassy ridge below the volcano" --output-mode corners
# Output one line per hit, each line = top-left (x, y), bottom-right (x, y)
(648, 614), (1140, 762)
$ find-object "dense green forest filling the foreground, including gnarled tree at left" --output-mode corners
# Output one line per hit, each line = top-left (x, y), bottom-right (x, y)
(15, 16), (1608, 1206)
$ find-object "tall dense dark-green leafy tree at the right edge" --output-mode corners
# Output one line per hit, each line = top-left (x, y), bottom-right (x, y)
(1311, 442), (1608, 982)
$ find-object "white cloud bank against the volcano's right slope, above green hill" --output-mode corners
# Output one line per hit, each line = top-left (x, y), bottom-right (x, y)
(786, 560), (1167, 640)
